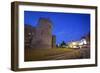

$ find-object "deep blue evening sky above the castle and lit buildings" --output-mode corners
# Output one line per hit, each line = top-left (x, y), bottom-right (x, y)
(24, 11), (90, 44)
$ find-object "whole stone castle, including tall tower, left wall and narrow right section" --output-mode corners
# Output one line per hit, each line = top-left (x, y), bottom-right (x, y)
(25, 18), (56, 49)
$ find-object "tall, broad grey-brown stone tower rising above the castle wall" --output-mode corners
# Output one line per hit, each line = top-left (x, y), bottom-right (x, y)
(32, 18), (52, 49)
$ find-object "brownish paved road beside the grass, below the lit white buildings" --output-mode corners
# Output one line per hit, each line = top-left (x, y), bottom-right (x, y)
(44, 48), (90, 60)
